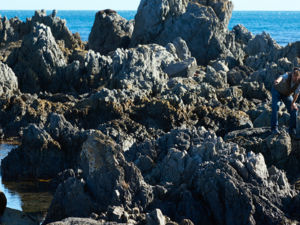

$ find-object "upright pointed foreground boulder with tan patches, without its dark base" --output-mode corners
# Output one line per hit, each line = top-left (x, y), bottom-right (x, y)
(80, 131), (153, 211)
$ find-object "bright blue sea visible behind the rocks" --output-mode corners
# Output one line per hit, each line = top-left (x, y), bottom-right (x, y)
(0, 10), (300, 46)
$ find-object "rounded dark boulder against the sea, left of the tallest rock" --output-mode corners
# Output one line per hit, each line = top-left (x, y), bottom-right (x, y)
(88, 10), (134, 54)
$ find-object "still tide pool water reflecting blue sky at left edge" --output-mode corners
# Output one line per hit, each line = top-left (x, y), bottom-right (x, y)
(0, 144), (53, 221)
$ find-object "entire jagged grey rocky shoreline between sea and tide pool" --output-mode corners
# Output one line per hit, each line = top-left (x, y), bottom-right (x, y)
(0, 0), (300, 225)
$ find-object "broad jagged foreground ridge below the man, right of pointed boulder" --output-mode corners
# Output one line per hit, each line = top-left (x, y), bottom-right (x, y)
(127, 128), (295, 224)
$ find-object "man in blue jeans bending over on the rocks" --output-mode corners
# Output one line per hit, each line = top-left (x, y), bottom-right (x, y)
(271, 67), (300, 137)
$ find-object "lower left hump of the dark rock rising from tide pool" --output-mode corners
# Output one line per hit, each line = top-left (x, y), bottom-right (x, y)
(1, 124), (64, 180)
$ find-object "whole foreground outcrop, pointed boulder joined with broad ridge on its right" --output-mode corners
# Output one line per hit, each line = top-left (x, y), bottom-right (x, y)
(42, 128), (296, 224)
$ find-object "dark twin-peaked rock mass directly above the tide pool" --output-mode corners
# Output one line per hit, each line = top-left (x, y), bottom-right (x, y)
(1, 113), (89, 180)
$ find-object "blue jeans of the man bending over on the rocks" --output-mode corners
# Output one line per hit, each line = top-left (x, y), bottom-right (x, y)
(271, 88), (298, 130)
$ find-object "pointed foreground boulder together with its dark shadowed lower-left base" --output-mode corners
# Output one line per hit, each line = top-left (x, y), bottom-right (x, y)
(45, 131), (153, 223)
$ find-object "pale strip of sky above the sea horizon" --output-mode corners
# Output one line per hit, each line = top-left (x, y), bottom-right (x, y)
(0, 0), (300, 11)
